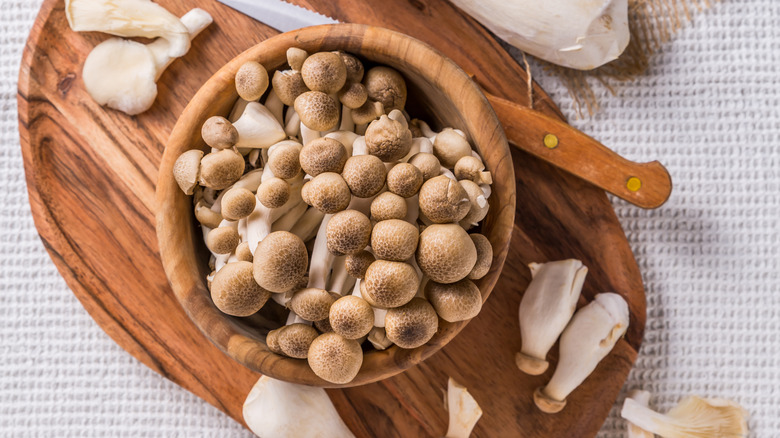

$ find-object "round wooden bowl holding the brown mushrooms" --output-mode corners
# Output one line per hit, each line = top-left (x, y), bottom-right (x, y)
(157, 24), (515, 387)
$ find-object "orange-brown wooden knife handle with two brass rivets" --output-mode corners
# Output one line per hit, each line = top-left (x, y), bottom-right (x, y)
(486, 93), (672, 208)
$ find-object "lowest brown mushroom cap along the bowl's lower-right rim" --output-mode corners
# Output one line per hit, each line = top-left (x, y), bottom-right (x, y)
(385, 298), (439, 348)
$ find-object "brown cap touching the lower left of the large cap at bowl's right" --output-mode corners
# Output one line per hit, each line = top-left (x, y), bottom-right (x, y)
(360, 260), (420, 309)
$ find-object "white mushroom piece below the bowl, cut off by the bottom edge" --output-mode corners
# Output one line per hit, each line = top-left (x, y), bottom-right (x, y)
(243, 376), (354, 438)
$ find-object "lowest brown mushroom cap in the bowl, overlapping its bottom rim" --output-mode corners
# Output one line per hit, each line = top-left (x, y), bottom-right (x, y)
(308, 333), (363, 384)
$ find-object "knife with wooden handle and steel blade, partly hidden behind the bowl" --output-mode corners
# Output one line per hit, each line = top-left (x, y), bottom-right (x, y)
(217, 0), (672, 208)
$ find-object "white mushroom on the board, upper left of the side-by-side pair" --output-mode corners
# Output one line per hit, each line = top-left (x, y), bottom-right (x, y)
(515, 259), (588, 376)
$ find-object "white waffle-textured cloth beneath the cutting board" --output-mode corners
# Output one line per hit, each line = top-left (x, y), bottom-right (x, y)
(0, 0), (780, 438)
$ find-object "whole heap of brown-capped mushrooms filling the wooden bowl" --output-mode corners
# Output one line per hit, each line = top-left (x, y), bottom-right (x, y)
(173, 48), (493, 384)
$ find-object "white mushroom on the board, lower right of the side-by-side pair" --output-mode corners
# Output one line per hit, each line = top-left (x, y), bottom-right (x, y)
(534, 292), (628, 414)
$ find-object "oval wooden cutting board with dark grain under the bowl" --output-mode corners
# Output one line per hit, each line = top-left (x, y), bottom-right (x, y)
(18, 0), (645, 437)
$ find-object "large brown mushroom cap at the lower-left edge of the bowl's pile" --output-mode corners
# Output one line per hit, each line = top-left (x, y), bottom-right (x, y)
(211, 262), (271, 316)
